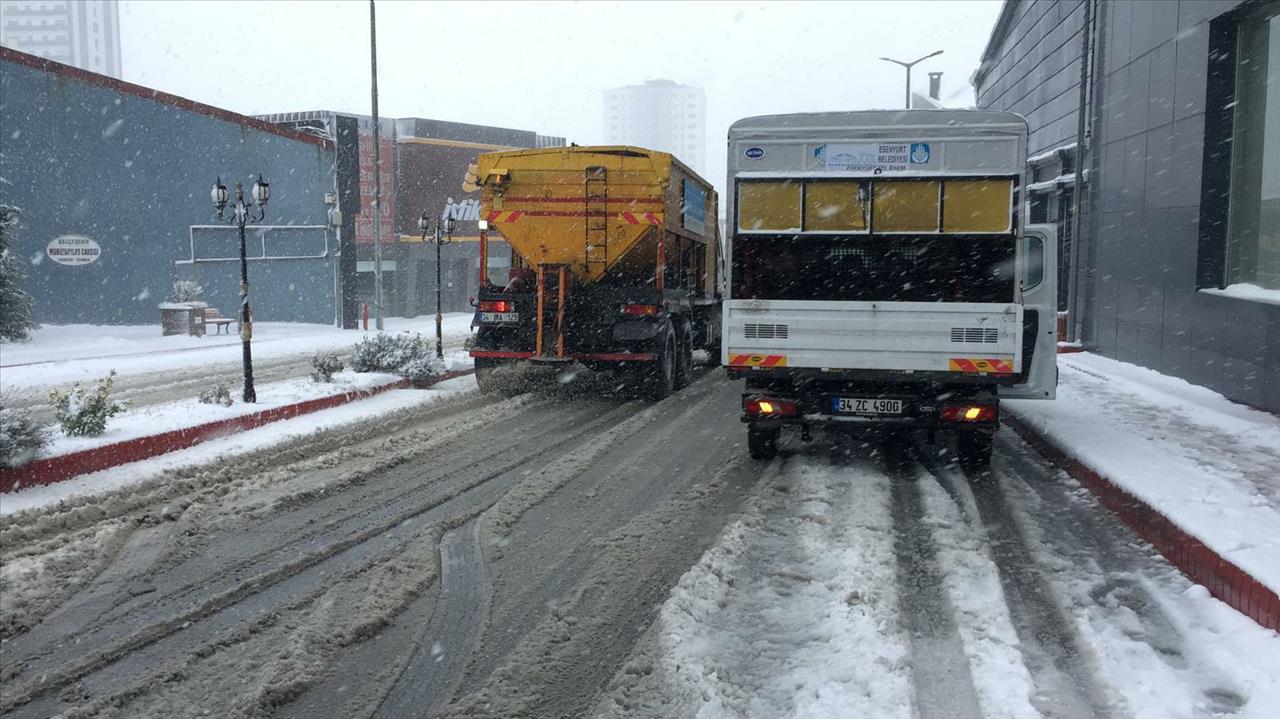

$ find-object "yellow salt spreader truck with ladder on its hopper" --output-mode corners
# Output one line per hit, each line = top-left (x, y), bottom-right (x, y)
(463, 146), (721, 399)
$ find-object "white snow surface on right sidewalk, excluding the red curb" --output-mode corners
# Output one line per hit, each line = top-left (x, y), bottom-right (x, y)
(1006, 353), (1280, 592)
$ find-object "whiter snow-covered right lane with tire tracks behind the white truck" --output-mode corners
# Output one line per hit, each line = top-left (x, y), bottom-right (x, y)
(594, 430), (1280, 719)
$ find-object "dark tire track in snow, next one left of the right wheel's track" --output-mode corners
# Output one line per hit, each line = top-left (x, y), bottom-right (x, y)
(884, 440), (982, 719)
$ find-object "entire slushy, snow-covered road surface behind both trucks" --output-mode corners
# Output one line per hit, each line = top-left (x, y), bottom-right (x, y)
(0, 371), (1280, 719)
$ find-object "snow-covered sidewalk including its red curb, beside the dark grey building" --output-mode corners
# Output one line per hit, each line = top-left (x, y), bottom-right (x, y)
(1006, 353), (1280, 628)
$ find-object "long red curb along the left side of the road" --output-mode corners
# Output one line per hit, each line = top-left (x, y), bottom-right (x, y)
(0, 370), (474, 493)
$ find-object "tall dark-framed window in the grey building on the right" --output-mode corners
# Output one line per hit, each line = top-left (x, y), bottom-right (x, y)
(1222, 6), (1280, 289)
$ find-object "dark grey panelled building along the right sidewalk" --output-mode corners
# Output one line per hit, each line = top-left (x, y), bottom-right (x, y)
(973, 0), (1280, 412)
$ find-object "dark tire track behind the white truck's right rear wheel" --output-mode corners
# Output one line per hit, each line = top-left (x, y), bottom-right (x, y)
(918, 442), (1110, 719)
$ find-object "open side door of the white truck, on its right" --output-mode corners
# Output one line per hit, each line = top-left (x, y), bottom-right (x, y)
(1000, 225), (1057, 399)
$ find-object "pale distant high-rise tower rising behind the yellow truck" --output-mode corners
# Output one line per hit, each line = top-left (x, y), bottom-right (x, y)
(604, 79), (707, 174)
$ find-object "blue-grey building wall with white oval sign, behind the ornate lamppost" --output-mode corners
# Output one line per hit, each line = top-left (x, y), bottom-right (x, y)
(0, 47), (340, 334)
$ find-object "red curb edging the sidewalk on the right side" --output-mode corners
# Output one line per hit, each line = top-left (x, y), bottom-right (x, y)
(1002, 413), (1280, 631)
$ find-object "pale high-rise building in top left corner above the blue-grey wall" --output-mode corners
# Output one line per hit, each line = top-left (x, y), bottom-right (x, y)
(0, 0), (120, 79)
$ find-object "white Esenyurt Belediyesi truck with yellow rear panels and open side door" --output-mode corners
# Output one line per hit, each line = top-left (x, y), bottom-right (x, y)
(721, 110), (1057, 466)
